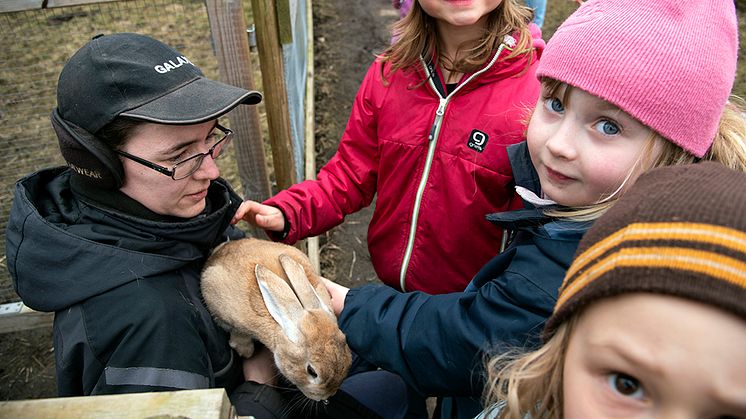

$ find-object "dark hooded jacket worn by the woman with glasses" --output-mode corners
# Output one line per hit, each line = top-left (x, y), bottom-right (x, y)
(6, 168), (243, 396)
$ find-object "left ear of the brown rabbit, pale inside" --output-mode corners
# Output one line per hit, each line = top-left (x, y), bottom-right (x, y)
(254, 264), (304, 343)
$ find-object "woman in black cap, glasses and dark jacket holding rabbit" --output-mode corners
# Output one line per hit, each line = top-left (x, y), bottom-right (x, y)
(6, 33), (396, 418)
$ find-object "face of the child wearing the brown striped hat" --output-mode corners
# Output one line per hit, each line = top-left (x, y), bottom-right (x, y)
(563, 293), (746, 419)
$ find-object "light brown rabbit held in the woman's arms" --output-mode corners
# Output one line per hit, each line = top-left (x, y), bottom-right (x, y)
(202, 238), (352, 400)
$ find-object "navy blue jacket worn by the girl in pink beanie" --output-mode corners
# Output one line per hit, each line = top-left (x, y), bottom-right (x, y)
(339, 143), (589, 418)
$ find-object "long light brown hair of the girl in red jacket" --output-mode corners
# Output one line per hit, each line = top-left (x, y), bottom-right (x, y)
(379, 0), (533, 81)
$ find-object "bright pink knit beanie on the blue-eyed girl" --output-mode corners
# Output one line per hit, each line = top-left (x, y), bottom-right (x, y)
(536, 0), (738, 157)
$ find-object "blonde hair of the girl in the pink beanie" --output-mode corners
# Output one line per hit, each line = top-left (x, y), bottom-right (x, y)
(542, 78), (746, 221)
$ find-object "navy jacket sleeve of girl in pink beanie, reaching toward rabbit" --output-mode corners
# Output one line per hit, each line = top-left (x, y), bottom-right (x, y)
(339, 248), (562, 396)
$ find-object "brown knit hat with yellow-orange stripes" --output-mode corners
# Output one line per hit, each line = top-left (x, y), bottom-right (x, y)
(544, 162), (746, 340)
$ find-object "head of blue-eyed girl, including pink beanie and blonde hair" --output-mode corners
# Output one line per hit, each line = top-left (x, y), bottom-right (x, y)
(528, 0), (746, 218)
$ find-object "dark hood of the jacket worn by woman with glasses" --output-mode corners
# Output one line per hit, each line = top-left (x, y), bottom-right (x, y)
(6, 168), (241, 311)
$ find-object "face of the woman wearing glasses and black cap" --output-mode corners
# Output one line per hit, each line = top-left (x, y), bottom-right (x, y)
(120, 120), (220, 218)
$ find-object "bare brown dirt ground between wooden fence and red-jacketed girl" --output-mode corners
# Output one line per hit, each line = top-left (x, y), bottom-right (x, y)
(313, 0), (398, 287)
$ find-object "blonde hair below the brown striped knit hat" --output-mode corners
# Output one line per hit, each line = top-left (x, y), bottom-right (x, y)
(484, 315), (577, 419)
